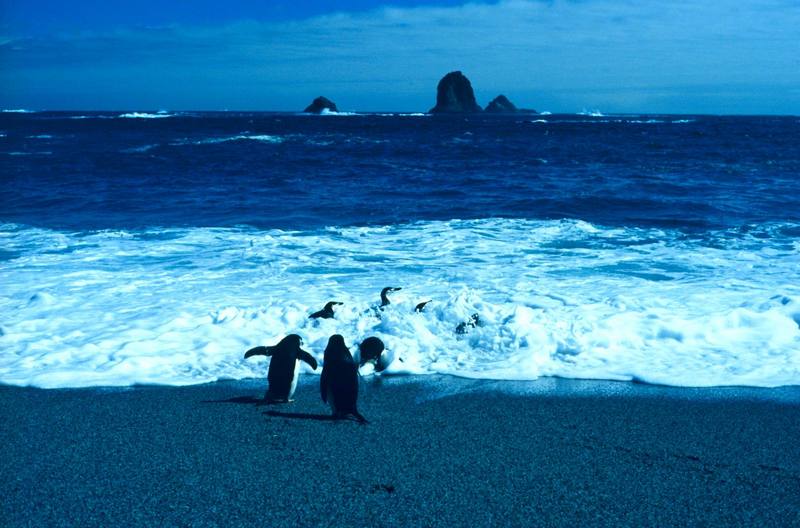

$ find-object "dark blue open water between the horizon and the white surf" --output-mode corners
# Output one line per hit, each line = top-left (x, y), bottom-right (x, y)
(0, 112), (800, 232)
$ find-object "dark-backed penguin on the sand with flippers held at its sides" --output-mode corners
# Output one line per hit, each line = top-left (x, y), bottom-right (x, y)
(319, 334), (367, 423)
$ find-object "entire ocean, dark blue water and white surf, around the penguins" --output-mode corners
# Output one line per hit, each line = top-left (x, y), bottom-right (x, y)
(0, 112), (800, 388)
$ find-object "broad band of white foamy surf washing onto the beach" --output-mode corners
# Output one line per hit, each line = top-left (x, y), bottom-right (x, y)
(0, 219), (800, 387)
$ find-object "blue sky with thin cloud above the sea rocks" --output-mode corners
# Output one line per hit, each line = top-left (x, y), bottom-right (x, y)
(0, 0), (800, 115)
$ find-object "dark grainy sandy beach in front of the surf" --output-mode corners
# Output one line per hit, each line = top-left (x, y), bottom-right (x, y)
(0, 376), (800, 526)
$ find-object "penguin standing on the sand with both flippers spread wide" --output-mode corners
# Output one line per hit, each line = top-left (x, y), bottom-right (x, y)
(244, 334), (317, 403)
